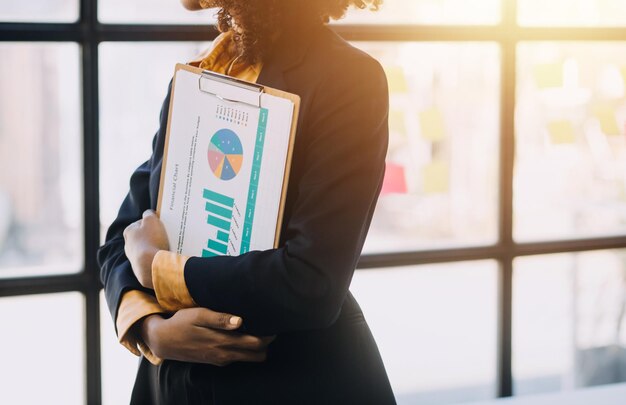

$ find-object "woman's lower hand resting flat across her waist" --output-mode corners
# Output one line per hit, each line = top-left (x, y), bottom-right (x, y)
(138, 308), (275, 366)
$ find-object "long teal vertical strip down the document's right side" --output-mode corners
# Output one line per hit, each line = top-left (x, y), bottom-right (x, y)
(240, 108), (269, 254)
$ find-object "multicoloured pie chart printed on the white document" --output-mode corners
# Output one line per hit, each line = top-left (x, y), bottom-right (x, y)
(207, 129), (243, 180)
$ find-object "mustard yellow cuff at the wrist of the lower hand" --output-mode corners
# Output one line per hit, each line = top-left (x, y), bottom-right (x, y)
(115, 290), (166, 365)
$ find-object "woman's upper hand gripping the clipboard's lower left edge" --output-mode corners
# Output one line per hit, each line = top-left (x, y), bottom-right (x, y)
(124, 210), (169, 289)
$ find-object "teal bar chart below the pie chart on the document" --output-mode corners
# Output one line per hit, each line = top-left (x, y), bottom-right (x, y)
(202, 189), (235, 257)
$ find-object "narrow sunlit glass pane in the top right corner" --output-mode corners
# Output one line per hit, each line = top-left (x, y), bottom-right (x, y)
(518, 0), (626, 27)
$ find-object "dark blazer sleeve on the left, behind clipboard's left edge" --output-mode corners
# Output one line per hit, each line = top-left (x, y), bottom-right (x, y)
(97, 81), (172, 333)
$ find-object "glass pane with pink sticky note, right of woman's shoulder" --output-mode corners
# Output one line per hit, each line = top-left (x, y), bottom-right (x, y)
(357, 42), (500, 253)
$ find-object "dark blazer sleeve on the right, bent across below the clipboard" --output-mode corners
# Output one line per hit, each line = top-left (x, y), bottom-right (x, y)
(179, 57), (389, 335)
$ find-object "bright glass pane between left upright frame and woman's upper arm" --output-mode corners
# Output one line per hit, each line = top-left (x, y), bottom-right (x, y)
(100, 42), (210, 232)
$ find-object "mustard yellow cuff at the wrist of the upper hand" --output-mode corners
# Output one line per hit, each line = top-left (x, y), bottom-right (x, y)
(152, 250), (197, 312)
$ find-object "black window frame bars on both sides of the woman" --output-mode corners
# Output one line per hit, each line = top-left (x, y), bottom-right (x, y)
(0, 0), (626, 405)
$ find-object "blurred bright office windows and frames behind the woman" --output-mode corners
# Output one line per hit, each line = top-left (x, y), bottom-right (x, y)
(0, 0), (626, 405)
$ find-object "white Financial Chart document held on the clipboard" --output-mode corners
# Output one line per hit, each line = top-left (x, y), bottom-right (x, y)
(159, 65), (294, 257)
